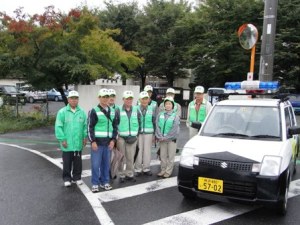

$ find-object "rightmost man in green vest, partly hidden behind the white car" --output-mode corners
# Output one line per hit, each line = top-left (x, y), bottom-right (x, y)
(186, 86), (212, 139)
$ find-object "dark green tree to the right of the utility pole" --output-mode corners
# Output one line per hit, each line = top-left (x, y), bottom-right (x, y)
(274, 0), (300, 92)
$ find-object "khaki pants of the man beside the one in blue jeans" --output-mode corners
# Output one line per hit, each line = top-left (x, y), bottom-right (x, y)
(117, 137), (137, 178)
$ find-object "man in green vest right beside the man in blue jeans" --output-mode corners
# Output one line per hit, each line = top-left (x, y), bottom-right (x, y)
(115, 91), (141, 183)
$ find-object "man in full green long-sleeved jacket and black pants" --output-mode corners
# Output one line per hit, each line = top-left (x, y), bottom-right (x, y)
(55, 91), (87, 187)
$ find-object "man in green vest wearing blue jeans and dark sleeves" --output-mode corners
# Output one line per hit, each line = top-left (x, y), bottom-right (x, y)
(88, 88), (117, 192)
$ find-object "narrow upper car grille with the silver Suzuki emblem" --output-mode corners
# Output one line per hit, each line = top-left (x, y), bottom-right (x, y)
(199, 158), (252, 172)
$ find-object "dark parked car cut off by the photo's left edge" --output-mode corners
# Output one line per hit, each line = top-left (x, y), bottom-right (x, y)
(0, 85), (26, 105)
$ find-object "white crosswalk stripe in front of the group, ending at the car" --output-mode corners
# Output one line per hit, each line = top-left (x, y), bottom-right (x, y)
(95, 177), (177, 202)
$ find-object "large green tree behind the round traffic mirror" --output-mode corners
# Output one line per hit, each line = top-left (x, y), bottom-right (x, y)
(186, 0), (264, 87)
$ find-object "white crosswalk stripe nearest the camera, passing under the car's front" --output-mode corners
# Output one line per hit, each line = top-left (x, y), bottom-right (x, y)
(146, 180), (300, 225)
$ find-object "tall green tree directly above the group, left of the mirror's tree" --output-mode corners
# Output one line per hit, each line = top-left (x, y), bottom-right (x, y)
(135, 0), (190, 86)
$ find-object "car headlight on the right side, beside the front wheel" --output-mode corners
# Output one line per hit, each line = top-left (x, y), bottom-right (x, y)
(259, 155), (282, 176)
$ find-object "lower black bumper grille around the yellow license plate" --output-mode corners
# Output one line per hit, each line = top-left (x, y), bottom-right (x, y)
(194, 177), (257, 199)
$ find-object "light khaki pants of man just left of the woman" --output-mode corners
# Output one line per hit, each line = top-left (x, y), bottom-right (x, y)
(135, 134), (153, 173)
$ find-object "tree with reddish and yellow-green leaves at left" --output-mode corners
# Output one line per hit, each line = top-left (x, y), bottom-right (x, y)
(0, 7), (142, 102)
